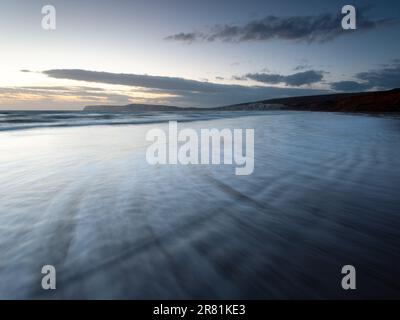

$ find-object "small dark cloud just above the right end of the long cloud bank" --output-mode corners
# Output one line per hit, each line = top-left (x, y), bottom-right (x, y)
(246, 70), (324, 87)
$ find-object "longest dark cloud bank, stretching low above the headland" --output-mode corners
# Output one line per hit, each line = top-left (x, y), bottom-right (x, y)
(43, 69), (326, 107)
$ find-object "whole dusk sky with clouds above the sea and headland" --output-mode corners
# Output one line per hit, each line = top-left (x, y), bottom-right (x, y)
(0, 0), (400, 110)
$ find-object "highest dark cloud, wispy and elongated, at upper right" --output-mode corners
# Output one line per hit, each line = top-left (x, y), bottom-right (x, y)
(166, 7), (398, 43)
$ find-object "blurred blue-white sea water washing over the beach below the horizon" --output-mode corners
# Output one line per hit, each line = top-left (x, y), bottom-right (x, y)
(0, 111), (400, 299)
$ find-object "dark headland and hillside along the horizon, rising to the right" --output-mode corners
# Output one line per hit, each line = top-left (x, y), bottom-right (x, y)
(84, 89), (400, 113)
